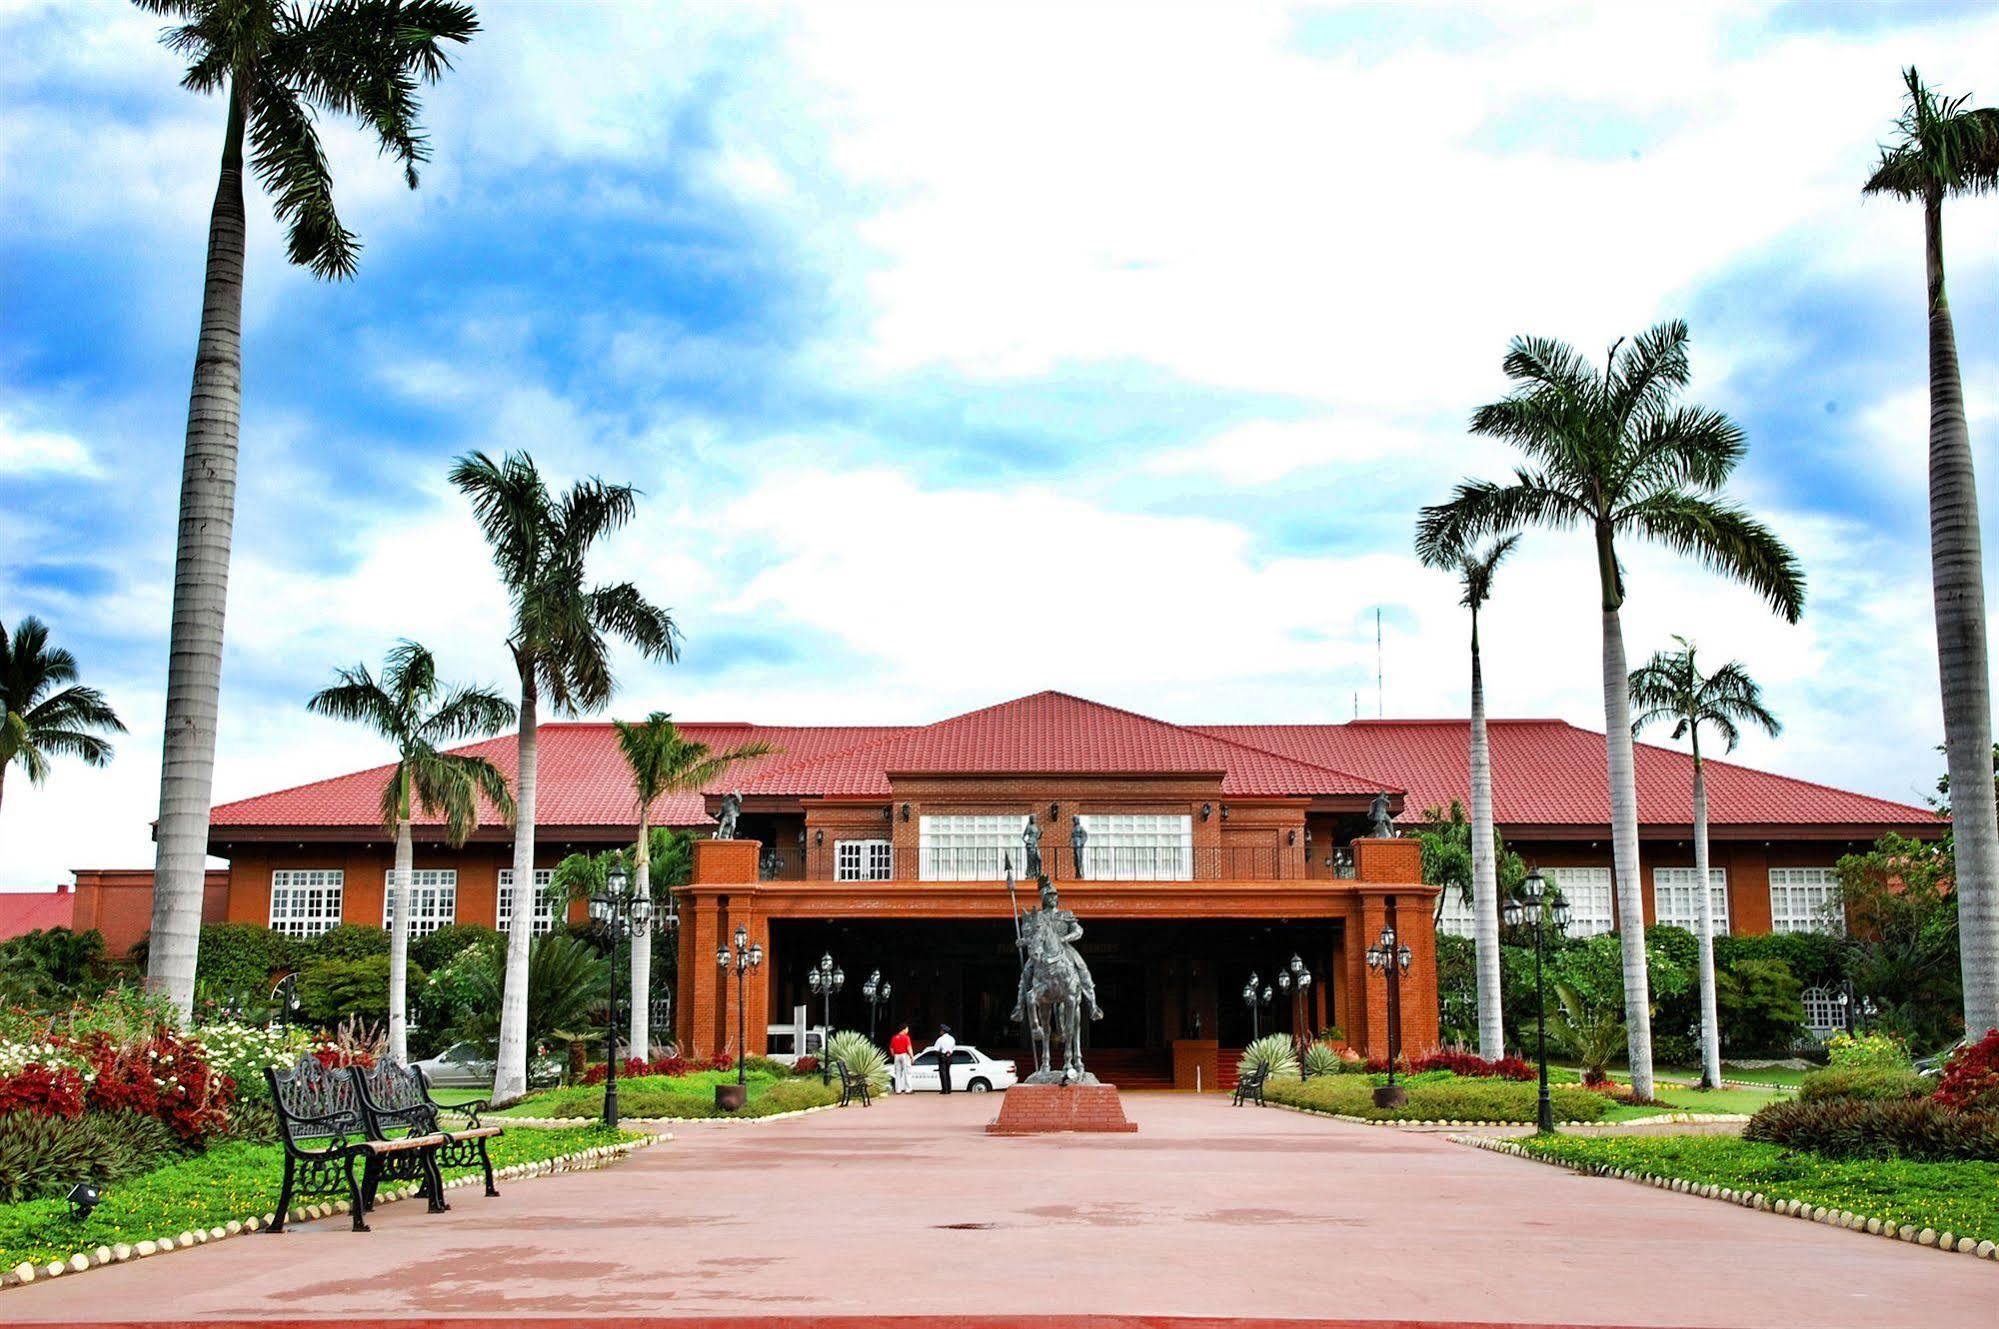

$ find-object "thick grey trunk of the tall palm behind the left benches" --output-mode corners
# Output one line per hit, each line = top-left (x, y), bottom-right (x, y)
(146, 80), (244, 1015)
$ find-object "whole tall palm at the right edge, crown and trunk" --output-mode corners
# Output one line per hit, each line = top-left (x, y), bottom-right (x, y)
(1863, 68), (1999, 1031)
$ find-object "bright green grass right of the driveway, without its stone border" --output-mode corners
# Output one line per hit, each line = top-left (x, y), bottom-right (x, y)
(1521, 1135), (1999, 1241)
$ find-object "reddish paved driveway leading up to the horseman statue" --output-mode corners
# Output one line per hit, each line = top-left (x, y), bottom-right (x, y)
(0, 1093), (1999, 1329)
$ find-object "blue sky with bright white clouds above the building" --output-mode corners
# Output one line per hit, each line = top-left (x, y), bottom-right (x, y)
(0, 0), (1999, 887)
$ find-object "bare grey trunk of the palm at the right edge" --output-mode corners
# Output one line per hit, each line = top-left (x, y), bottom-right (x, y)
(1923, 190), (1999, 1037)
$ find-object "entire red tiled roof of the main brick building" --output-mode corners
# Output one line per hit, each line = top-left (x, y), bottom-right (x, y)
(210, 691), (1933, 829)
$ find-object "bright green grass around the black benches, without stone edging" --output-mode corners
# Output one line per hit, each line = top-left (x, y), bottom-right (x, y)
(0, 1125), (640, 1269)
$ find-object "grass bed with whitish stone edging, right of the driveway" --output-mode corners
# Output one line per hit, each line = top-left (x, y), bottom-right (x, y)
(1465, 1135), (1999, 1259)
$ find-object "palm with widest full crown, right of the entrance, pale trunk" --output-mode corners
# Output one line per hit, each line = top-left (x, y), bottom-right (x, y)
(1415, 320), (1805, 1097)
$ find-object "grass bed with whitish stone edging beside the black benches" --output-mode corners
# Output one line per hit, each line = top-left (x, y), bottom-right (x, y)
(0, 1125), (652, 1283)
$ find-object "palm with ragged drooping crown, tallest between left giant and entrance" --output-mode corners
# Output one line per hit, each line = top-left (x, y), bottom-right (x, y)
(452, 452), (680, 1105)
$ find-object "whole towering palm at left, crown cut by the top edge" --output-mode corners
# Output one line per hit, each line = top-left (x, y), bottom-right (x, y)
(134, 0), (478, 1015)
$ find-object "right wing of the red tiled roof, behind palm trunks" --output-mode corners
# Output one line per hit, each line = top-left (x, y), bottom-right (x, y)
(1197, 719), (1935, 825)
